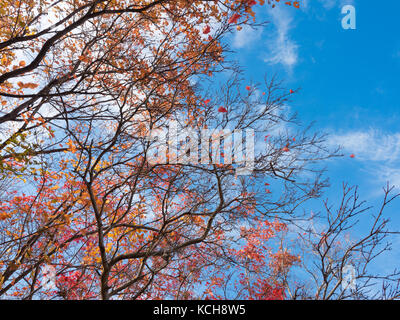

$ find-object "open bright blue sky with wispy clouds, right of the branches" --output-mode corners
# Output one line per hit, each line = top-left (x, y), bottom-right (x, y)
(231, 0), (400, 272)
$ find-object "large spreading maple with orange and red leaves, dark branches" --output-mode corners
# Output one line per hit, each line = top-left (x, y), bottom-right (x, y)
(0, 0), (396, 299)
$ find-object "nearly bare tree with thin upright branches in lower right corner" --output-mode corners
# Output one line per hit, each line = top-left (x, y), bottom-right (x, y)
(286, 184), (400, 300)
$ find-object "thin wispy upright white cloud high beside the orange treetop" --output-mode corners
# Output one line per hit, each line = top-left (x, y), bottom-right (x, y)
(264, 7), (298, 69)
